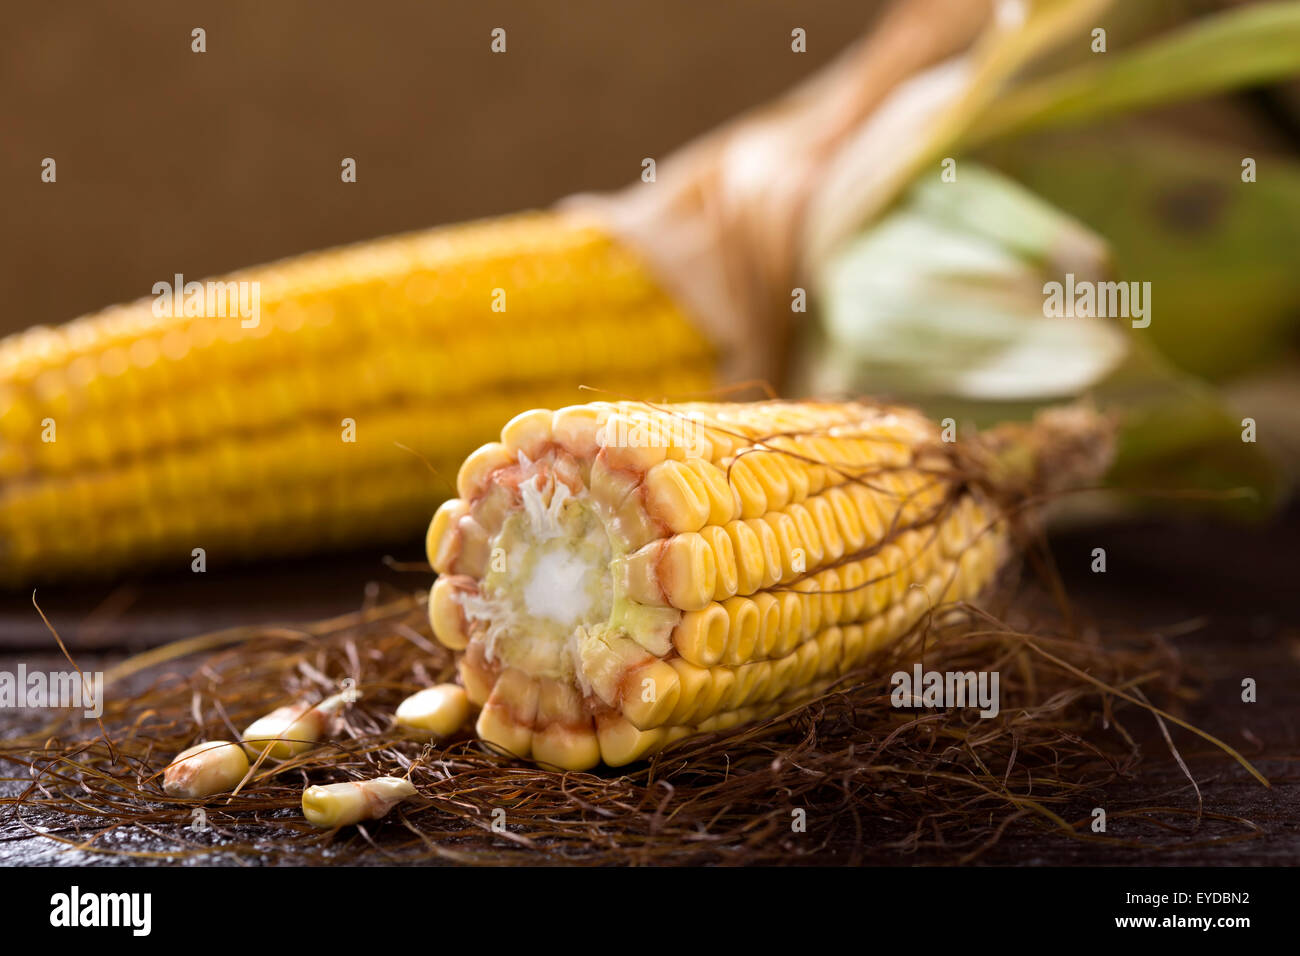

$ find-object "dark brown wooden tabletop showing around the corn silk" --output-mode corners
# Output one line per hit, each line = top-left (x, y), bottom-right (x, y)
(0, 507), (1300, 865)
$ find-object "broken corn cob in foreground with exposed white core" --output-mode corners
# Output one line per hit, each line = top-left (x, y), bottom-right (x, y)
(428, 402), (1109, 769)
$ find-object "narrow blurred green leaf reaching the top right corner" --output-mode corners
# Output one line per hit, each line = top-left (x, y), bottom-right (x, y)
(961, 3), (1300, 148)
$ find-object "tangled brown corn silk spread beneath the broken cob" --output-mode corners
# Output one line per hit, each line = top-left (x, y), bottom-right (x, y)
(0, 541), (1258, 864)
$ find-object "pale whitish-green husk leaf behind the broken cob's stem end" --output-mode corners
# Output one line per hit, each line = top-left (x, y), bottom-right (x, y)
(810, 163), (1125, 401)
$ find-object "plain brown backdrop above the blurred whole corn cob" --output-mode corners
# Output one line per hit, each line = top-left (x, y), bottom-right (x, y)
(0, 0), (879, 333)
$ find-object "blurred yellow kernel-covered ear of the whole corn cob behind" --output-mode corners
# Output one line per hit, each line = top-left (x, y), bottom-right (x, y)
(0, 212), (715, 583)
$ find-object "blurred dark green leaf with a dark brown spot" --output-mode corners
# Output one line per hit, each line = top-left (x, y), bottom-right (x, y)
(984, 125), (1300, 381)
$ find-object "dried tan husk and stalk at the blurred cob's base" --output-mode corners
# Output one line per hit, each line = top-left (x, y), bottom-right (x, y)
(562, 0), (992, 382)
